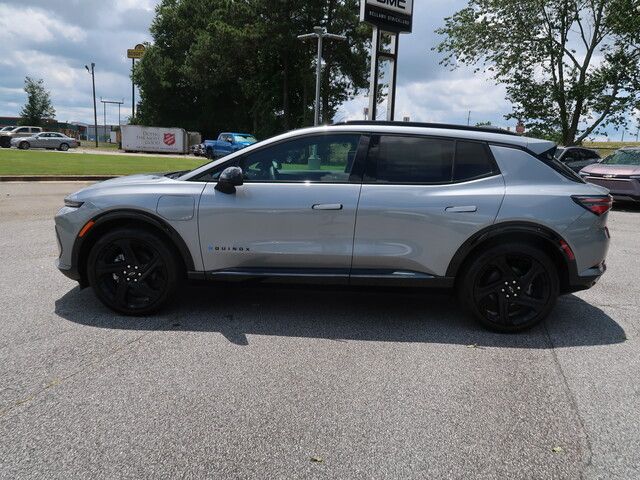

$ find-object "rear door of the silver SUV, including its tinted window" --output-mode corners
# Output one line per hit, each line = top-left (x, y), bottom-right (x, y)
(351, 135), (505, 283)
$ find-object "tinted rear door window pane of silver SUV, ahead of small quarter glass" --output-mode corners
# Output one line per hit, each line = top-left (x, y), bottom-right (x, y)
(373, 136), (454, 183)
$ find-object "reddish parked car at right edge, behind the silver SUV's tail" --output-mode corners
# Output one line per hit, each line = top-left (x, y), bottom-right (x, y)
(580, 147), (640, 202)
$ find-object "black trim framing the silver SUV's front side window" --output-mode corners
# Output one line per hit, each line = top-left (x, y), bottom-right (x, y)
(187, 130), (370, 185)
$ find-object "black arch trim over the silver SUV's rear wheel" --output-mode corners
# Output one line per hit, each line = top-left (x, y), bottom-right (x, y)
(446, 221), (578, 285)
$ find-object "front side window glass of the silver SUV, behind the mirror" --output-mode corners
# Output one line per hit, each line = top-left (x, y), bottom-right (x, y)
(240, 134), (360, 183)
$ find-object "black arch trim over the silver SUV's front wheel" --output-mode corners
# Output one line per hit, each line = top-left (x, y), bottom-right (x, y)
(67, 209), (195, 288)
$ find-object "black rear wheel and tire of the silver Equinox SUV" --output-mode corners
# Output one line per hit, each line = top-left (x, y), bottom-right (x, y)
(458, 243), (560, 332)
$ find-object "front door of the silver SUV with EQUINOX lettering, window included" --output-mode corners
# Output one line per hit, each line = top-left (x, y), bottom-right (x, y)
(199, 134), (362, 281)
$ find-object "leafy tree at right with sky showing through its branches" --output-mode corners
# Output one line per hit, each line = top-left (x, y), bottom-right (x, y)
(436, 0), (640, 145)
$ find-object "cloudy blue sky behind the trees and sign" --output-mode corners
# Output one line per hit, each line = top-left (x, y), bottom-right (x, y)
(0, 0), (632, 139)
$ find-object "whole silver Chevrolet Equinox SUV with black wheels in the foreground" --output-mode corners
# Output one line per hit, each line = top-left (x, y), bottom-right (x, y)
(55, 122), (611, 331)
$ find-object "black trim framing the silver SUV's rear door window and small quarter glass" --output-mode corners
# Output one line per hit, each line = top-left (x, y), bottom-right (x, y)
(362, 133), (501, 186)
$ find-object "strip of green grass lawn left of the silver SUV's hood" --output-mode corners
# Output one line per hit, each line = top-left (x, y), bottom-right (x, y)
(0, 148), (206, 175)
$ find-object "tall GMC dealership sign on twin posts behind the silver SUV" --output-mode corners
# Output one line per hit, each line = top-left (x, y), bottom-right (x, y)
(360, 0), (413, 121)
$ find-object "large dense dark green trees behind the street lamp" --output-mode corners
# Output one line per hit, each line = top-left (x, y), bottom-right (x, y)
(134, 0), (370, 137)
